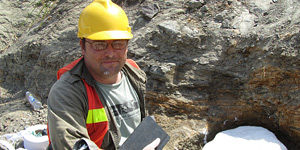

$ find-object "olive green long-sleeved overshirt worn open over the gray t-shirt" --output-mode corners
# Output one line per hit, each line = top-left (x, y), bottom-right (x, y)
(47, 59), (147, 150)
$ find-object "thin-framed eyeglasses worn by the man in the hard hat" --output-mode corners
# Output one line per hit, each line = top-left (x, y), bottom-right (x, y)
(85, 40), (128, 51)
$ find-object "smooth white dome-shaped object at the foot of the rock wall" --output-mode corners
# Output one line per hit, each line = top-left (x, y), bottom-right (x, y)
(202, 126), (287, 150)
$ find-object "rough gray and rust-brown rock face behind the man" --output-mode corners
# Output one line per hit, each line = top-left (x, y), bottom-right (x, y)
(0, 0), (300, 150)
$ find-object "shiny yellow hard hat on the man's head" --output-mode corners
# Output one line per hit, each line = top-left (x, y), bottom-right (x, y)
(78, 0), (133, 40)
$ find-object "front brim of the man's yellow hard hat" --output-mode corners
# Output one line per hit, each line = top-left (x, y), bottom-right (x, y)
(82, 31), (133, 40)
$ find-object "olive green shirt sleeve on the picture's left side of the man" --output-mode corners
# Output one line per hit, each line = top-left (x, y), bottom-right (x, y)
(47, 80), (98, 150)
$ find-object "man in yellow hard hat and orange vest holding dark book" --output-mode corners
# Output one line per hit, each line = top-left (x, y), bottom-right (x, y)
(48, 0), (159, 150)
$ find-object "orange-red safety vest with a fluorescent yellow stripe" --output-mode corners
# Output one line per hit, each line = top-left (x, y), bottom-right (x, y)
(48, 57), (140, 148)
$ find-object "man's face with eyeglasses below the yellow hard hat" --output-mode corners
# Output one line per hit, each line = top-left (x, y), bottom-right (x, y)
(80, 39), (128, 79)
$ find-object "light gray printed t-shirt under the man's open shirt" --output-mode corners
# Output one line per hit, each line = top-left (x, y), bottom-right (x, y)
(97, 72), (141, 145)
